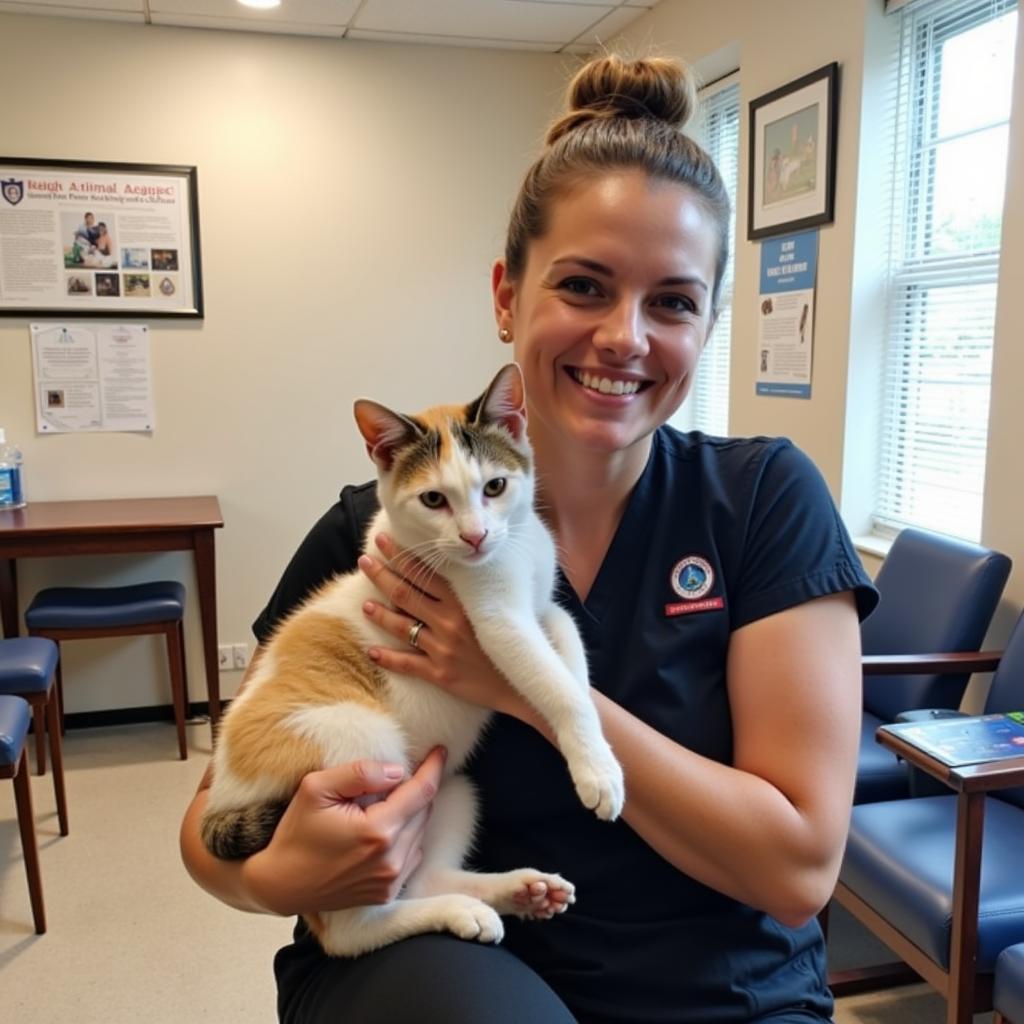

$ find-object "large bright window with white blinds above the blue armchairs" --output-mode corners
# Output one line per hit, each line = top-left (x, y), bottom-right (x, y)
(865, 0), (1017, 540)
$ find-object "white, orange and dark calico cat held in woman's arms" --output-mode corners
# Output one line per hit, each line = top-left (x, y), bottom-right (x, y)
(203, 364), (625, 956)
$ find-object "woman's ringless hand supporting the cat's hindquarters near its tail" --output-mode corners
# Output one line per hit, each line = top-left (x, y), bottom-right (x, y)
(242, 748), (444, 915)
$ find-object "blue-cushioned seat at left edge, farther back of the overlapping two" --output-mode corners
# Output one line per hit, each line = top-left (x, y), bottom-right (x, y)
(0, 637), (68, 836)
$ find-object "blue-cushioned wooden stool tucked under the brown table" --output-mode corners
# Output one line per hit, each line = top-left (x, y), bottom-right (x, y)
(25, 581), (188, 761)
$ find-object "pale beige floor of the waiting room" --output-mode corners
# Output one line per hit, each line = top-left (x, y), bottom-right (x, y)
(0, 724), (991, 1024)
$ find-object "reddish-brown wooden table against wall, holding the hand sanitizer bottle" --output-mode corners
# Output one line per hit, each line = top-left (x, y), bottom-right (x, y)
(0, 496), (224, 728)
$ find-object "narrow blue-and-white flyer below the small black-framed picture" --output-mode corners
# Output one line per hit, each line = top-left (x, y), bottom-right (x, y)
(757, 230), (818, 398)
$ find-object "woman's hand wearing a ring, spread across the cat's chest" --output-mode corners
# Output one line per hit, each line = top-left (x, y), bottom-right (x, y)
(359, 534), (535, 722)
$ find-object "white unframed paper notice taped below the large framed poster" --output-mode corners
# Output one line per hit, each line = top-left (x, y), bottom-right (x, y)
(31, 324), (155, 434)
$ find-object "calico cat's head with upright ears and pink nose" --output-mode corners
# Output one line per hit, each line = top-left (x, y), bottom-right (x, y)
(356, 364), (534, 573)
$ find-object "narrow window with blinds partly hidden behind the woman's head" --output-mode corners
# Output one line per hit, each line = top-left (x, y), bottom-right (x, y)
(673, 74), (739, 435)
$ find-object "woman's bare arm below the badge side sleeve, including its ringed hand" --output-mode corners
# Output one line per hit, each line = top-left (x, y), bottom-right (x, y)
(360, 540), (861, 925)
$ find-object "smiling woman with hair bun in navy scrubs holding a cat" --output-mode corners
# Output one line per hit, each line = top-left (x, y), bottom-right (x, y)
(182, 51), (877, 1024)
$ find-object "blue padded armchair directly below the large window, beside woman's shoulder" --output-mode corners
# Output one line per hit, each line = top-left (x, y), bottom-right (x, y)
(853, 529), (1011, 804)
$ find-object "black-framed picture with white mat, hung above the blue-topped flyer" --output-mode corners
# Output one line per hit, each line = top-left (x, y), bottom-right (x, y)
(746, 62), (839, 239)
